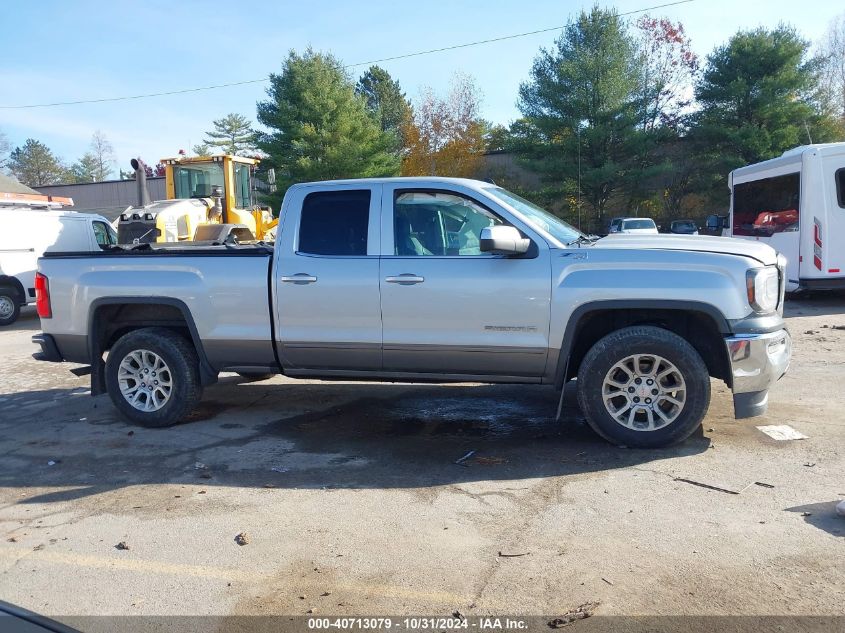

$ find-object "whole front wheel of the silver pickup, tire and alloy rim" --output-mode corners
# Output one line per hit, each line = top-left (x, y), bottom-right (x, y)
(578, 326), (710, 448)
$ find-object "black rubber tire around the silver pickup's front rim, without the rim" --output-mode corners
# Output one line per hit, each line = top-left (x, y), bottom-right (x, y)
(578, 326), (710, 448)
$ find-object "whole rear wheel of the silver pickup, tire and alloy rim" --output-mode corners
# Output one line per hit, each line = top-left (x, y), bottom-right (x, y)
(106, 328), (202, 428)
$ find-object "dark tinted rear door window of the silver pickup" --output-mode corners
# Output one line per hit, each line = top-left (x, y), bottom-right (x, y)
(297, 189), (371, 257)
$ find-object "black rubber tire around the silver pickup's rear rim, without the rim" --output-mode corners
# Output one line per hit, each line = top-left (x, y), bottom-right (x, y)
(106, 327), (202, 428)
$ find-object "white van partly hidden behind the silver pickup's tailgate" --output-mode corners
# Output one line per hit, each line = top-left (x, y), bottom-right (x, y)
(0, 207), (117, 326)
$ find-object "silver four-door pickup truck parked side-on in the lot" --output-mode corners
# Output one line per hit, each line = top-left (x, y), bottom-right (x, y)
(28, 178), (791, 447)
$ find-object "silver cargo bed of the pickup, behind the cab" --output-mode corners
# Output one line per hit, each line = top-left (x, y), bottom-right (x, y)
(39, 243), (276, 371)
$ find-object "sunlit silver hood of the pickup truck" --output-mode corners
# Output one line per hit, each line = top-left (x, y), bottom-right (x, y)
(593, 234), (777, 266)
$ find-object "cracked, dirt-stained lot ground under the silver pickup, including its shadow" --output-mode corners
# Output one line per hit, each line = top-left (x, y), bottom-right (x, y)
(0, 295), (845, 617)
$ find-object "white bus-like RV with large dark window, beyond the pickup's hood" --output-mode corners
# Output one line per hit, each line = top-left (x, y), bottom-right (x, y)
(725, 143), (845, 292)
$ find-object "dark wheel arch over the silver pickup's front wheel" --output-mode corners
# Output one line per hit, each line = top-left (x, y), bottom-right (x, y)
(555, 299), (731, 389)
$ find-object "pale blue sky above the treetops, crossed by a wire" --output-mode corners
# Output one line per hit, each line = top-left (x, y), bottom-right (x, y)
(0, 0), (845, 173)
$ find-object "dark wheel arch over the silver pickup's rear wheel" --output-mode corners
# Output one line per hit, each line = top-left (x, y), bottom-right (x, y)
(88, 297), (217, 395)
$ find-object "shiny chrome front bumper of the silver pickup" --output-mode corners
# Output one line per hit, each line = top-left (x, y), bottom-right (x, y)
(725, 329), (792, 418)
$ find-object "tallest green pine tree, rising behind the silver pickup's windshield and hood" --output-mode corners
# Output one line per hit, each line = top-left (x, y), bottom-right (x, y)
(509, 7), (650, 231)
